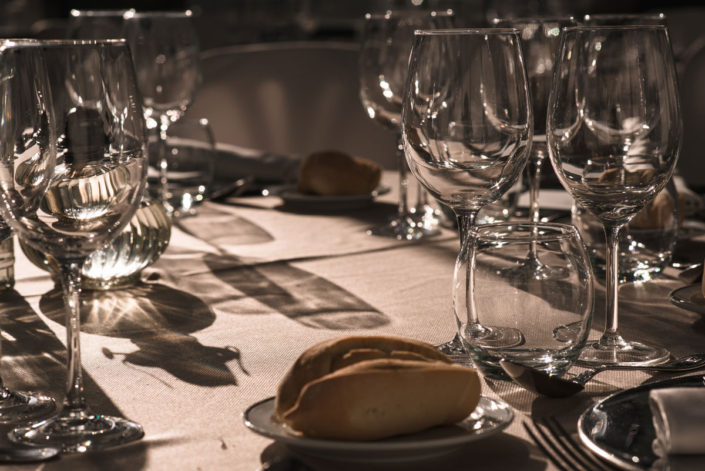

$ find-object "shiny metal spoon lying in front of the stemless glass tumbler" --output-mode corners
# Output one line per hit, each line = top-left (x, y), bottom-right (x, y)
(499, 353), (705, 397)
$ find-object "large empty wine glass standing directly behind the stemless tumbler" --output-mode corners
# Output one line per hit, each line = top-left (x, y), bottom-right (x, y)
(402, 28), (533, 362)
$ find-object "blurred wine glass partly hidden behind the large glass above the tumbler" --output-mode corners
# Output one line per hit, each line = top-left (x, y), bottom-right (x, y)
(359, 10), (453, 240)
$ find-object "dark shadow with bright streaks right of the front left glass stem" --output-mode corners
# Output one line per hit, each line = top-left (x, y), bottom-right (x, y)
(40, 283), (247, 387)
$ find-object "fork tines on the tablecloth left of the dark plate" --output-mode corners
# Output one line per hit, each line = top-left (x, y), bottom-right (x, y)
(522, 417), (615, 471)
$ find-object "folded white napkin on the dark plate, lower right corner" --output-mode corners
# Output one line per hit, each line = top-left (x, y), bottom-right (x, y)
(649, 387), (705, 458)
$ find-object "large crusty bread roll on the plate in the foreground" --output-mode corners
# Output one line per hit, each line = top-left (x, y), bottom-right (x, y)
(276, 336), (480, 440)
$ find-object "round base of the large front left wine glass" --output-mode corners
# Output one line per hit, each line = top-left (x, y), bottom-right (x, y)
(8, 414), (144, 453)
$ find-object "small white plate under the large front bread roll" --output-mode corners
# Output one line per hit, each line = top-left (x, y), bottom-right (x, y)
(243, 396), (514, 462)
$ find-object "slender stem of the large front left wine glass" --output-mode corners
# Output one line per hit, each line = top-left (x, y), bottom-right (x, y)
(61, 259), (86, 413)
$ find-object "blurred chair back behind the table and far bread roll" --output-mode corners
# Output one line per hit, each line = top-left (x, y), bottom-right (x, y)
(189, 42), (396, 168)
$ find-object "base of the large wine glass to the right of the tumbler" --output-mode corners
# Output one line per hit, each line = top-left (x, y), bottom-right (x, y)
(579, 340), (670, 366)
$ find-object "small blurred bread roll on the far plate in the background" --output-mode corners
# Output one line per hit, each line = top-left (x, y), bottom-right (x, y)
(298, 151), (382, 196)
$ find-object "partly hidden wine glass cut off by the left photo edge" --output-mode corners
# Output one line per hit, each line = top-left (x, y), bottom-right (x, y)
(0, 41), (55, 424)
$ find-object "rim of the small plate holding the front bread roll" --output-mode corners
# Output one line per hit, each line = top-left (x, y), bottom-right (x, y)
(242, 395), (515, 453)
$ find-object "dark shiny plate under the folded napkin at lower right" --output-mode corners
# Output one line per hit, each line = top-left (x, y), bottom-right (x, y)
(578, 374), (705, 470)
